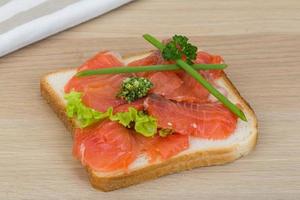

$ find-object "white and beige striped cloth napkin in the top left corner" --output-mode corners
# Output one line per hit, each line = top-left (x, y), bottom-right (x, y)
(0, 0), (132, 57)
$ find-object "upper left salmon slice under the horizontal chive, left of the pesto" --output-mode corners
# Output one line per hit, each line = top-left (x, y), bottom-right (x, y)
(65, 51), (128, 112)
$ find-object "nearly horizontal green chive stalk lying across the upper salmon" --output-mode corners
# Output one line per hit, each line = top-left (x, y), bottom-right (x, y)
(76, 64), (227, 77)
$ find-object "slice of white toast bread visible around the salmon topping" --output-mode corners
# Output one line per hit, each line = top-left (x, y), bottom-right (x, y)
(41, 53), (257, 191)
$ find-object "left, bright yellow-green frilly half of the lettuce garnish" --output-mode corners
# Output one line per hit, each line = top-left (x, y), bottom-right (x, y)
(64, 91), (113, 128)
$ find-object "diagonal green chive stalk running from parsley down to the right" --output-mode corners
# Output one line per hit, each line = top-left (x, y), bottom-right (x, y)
(143, 34), (247, 121)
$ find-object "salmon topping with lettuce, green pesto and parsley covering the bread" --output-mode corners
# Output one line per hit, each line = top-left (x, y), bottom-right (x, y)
(65, 36), (242, 171)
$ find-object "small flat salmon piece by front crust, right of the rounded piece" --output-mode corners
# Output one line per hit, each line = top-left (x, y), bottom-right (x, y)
(136, 133), (189, 162)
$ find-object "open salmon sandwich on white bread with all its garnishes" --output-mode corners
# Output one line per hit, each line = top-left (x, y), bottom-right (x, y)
(41, 34), (257, 191)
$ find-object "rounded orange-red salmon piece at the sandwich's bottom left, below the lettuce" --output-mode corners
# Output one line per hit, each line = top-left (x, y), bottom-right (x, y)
(73, 121), (139, 171)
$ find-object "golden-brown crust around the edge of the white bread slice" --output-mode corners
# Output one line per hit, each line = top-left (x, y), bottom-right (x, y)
(40, 54), (258, 191)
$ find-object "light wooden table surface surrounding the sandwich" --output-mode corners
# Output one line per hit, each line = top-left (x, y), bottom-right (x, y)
(0, 0), (300, 200)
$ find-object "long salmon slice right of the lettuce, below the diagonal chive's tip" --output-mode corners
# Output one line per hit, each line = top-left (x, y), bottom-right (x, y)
(145, 94), (237, 140)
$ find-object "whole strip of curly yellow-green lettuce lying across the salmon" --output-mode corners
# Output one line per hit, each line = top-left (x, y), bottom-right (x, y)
(64, 91), (157, 137)
